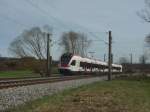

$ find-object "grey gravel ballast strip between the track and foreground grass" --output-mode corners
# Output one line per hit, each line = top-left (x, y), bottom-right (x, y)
(0, 77), (106, 112)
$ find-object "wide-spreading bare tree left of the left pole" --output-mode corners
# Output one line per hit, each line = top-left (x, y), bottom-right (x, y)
(9, 27), (51, 60)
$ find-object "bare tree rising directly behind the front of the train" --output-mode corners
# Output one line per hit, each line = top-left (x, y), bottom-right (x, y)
(60, 31), (90, 56)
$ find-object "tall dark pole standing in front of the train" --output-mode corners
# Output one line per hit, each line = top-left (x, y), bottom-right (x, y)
(108, 31), (112, 81)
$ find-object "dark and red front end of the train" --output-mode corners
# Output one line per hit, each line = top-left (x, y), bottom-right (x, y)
(58, 53), (73, 75)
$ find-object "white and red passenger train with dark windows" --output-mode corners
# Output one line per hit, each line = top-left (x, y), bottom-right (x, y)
(58, 53), (122, 75)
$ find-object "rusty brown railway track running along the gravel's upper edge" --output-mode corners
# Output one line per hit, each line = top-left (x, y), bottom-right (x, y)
(0, 75), (97, 89)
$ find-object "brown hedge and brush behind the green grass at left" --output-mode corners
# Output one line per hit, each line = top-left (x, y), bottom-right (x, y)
(0, 57), (58, 73)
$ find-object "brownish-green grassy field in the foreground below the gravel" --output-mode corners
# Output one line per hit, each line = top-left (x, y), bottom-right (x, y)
(10, 75), (150, 112)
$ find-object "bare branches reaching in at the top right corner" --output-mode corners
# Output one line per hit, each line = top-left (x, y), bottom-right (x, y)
(137, 0), (150, 23)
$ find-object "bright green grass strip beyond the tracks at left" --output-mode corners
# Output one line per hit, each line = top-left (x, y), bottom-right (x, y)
(0, 70), (39, 78)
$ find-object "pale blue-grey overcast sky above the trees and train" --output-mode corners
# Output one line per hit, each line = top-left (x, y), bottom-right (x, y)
(0, 0), (150, 62)
